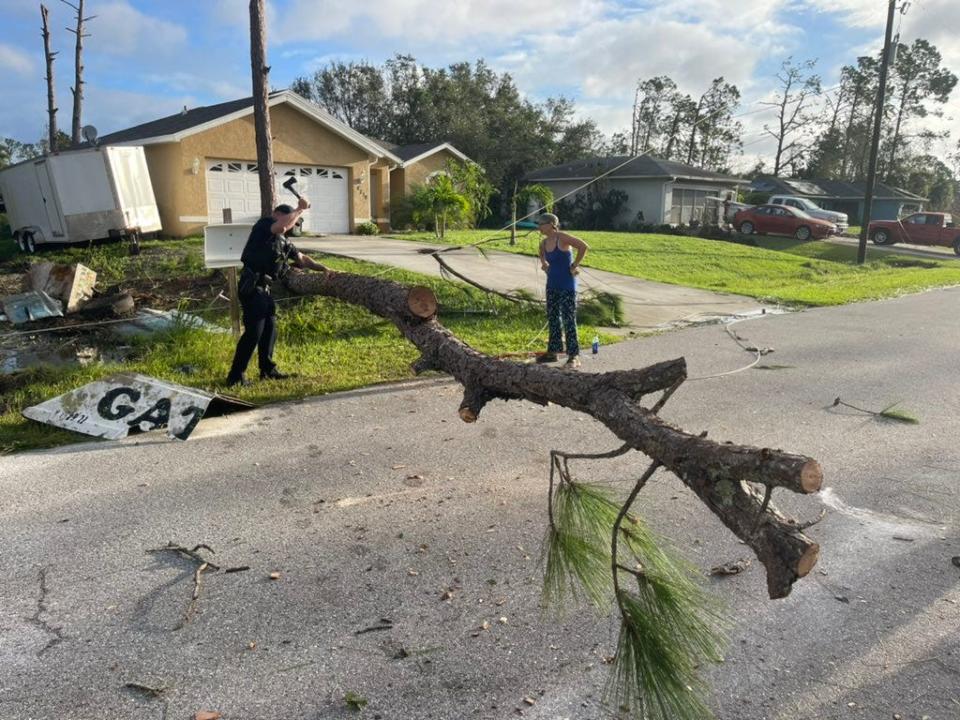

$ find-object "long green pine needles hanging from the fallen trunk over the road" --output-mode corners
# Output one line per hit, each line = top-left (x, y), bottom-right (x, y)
(544, 482), (725, 720)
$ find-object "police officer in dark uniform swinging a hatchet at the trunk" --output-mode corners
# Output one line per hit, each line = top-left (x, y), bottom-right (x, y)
(227, 198), (327, 386)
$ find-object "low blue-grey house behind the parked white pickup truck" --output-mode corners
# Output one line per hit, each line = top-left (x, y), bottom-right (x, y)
(750, 175), (929, 225)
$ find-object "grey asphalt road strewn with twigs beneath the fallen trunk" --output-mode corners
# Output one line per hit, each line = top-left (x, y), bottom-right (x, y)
(0, 289), (960, 720)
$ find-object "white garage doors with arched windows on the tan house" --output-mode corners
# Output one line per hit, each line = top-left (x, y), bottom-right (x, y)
(206, 160), (350, 233)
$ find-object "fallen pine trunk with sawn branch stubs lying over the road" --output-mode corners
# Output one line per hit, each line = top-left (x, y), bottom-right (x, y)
(286, 272), (823, 598)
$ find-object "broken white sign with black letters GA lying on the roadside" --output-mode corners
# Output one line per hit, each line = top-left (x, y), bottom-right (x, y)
(23, 373), (253, 440)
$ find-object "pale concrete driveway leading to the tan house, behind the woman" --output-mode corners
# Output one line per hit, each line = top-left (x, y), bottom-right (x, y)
(296, 235), (763, 329)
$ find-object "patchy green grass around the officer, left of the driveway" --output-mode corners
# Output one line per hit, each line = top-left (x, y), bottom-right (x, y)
(0, 240), (617, 454)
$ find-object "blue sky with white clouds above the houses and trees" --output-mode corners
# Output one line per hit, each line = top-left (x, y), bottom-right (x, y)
(0, 0), (960, 167)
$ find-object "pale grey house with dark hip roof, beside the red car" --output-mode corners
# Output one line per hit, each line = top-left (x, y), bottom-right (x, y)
(523, 155), (750, 225)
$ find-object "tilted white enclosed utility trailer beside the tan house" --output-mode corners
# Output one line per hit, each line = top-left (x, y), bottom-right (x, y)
(0, 145), (160, 252)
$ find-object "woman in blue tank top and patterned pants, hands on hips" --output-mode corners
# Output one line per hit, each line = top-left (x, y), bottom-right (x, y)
(537, 213), (588, 368)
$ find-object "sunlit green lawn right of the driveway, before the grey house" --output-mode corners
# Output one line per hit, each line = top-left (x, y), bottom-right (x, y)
(396, 230), (960, 306)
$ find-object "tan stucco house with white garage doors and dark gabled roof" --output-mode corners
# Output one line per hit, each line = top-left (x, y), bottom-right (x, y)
(100, 90), (466, 237)
